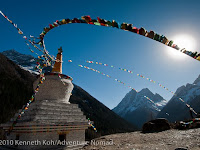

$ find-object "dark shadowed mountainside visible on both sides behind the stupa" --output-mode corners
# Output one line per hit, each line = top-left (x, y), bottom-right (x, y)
(0, 50), (136, 139)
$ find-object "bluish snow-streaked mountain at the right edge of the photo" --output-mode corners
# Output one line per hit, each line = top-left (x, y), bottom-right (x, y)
(157, 75), (200, 122)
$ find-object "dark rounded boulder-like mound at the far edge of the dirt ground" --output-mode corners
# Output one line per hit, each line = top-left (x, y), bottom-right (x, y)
(142, 118), (171, 133)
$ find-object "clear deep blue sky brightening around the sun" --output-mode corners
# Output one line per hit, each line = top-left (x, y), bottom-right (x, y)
(0, 0), (200, 109)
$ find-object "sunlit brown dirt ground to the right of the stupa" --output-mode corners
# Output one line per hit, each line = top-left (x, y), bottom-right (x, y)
(82, 128), (200, 150)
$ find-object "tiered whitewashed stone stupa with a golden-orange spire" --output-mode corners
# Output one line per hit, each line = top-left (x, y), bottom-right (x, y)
(1, 48), (89, 149)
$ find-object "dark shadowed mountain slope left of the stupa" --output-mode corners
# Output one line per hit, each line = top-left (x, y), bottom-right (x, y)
(0, 53), (36, 123)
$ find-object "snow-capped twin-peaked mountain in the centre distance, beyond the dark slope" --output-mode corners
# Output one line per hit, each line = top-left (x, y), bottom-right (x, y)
(113, 88), (167, 129)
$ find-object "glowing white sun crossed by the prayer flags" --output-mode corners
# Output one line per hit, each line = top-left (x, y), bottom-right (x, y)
(168, 34), (196, 59)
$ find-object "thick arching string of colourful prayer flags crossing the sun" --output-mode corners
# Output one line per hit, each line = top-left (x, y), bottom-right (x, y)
(38, 16), (200, 61)
